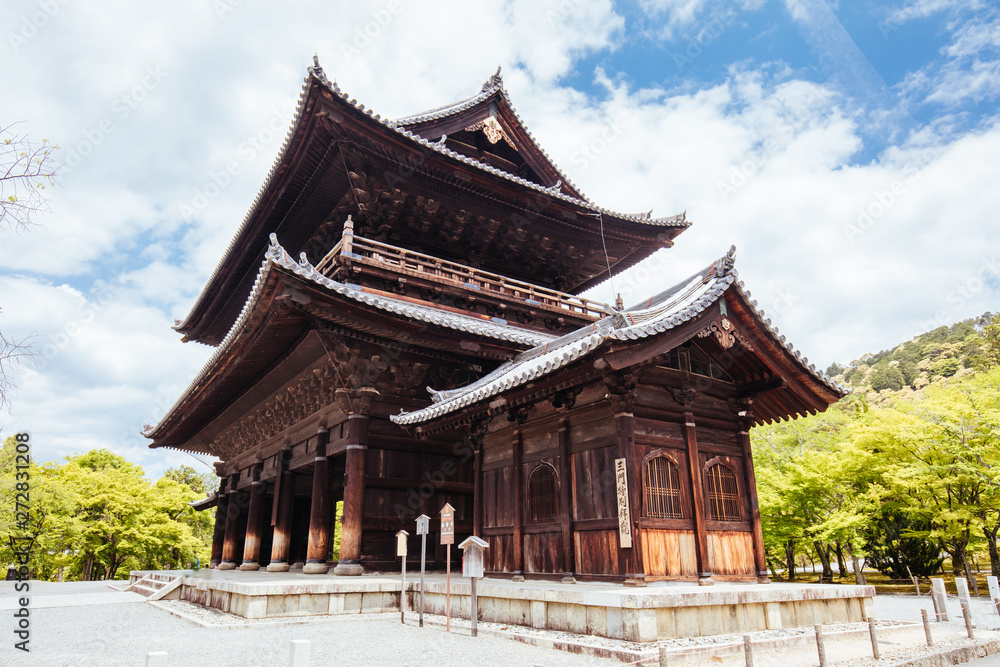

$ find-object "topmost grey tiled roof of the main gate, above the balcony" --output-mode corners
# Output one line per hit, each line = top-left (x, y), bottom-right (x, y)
(174, 62), (690, 345)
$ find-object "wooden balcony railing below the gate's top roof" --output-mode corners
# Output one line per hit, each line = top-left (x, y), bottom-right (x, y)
(316, 218), (607, 319)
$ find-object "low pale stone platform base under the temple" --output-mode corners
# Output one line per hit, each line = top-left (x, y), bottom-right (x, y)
(131, 570), (875, 642)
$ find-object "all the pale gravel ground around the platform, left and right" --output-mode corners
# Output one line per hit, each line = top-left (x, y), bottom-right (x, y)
(0, 582), (1000, 667)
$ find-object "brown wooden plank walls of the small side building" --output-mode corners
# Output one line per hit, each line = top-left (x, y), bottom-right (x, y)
(481, 374), (754, 579)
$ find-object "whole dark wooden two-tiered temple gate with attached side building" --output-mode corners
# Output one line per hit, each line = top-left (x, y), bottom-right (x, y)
(146, 63), (844, 584)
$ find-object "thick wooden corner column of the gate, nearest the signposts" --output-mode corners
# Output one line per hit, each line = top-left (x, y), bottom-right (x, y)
(333, 387), (378, 576)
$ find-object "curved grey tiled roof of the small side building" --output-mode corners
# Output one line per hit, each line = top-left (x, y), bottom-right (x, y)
(390, 247), (847, 426)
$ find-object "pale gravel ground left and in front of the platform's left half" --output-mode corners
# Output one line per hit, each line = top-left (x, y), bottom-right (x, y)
(0, 582), (612, 667)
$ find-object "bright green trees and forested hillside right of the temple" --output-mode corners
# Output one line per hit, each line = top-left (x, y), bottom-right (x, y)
(751, 313), (1000, 580)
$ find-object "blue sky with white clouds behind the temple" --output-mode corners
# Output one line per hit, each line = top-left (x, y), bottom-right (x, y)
(0, 0), (1000, 475)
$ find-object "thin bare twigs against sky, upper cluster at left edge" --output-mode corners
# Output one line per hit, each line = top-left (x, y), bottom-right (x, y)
(0, 123), (59, 231)
